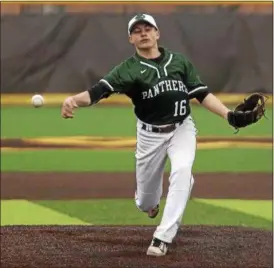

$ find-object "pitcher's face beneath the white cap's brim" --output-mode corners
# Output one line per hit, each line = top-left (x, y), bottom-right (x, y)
(129, 23), (160, 49)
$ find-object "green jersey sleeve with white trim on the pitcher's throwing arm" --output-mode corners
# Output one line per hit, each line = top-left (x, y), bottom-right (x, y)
(100, 62), (134, 94)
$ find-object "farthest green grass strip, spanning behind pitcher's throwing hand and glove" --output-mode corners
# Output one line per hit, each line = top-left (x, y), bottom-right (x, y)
(1, 106), (272, 138)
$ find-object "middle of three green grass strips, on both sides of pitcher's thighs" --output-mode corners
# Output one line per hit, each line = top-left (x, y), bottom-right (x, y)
(1, 149), (272, 172)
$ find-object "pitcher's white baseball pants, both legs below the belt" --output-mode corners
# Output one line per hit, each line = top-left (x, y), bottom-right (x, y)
(135, 116), (197, 243)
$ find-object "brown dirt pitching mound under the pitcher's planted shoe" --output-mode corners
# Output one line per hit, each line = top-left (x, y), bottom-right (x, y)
(1, 226), (272, 268)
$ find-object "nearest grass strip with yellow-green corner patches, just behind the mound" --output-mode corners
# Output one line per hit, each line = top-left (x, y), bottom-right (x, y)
(1, 199), (272, 229)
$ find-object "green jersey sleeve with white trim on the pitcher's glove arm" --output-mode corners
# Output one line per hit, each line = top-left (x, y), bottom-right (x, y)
(184, 56), (208, 99)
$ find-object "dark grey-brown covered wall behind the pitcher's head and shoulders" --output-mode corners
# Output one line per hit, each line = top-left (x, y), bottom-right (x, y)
(1, 2), (273, 93)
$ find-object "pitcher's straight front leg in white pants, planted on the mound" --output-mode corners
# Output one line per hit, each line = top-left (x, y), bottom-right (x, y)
(154, 117), (196, 243)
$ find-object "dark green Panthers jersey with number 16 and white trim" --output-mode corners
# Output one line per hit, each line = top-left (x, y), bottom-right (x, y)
(100, 48), (207, 125)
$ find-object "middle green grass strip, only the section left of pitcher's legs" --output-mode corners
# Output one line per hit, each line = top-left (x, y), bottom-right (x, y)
(1, 149), (134, 172)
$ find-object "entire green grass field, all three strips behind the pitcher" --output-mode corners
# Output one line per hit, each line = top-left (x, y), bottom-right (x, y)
(1, 106), (273, 229)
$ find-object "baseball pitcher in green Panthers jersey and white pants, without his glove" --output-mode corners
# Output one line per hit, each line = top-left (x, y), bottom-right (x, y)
(61, 14), (243, 256)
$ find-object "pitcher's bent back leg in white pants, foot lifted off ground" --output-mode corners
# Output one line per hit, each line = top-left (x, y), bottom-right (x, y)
(135, 122), (168, 215)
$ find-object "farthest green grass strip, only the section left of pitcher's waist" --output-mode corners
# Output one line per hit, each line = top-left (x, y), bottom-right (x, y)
(1, 106), (135, 138)
